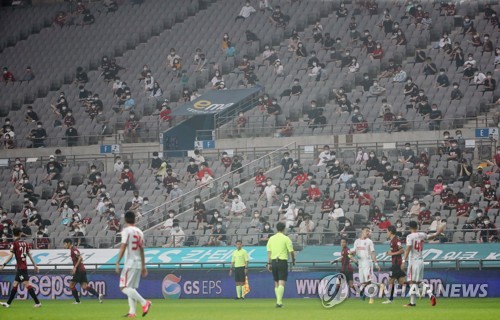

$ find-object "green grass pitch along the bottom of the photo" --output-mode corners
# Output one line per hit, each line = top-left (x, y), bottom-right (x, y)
(0, 298), (500, 320)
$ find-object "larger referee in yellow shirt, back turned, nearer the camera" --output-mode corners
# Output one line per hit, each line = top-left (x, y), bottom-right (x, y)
(267, 222), (295, 308)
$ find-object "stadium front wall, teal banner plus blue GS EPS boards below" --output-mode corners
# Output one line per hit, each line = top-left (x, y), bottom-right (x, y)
(0, 244), (500, 300)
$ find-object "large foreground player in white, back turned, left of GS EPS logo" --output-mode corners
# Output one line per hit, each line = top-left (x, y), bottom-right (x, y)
(116, 211), (151, 318)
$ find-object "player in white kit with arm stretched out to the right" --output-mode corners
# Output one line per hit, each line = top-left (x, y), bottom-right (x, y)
(401, 221), (443, 307)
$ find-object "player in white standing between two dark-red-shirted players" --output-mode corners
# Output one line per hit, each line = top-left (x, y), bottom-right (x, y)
(351, 227), (380, 303)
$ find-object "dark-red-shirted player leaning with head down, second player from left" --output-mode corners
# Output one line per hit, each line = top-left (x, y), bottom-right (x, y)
(63, 238), (103, 304)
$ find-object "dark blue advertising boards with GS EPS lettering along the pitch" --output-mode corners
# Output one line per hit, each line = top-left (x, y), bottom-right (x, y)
(0, 269), (500, 302)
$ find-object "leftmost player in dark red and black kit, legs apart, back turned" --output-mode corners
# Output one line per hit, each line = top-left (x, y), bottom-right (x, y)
(0, 228), (42, 308)
